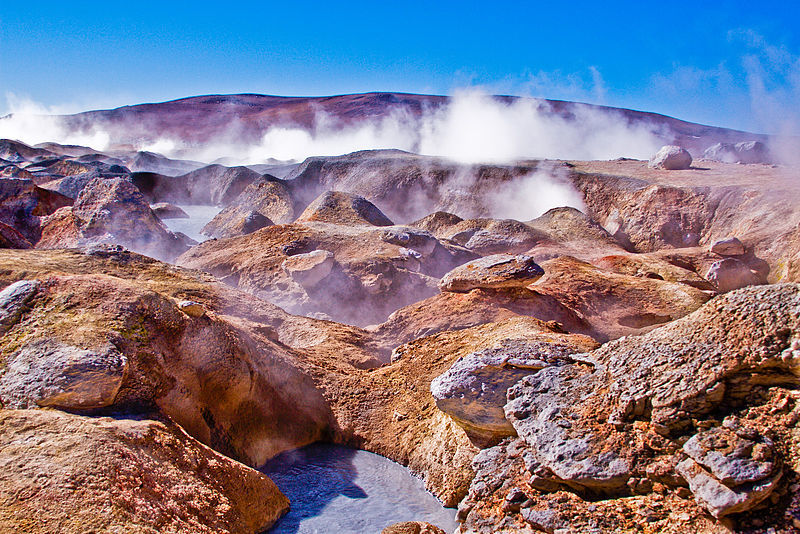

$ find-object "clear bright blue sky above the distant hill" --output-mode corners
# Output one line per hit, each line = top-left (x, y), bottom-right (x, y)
(0, 0), (800, 133)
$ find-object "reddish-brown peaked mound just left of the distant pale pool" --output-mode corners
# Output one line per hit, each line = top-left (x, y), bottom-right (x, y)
(36, 178), (188, 260)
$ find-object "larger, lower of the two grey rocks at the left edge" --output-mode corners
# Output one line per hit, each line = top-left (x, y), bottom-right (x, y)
(0, 339), (127, 410)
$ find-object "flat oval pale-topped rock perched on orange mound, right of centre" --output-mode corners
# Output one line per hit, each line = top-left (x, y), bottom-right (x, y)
(439, 254), (544, 293)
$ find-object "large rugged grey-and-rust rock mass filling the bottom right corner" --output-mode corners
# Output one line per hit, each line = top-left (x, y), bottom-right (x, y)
(459, 284), (800, 531)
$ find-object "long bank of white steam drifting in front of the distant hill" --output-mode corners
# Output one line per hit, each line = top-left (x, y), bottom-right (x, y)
(0, 90), (663, 164)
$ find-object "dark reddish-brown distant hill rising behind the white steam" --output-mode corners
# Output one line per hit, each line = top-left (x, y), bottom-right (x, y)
(56, 93), (768, 155)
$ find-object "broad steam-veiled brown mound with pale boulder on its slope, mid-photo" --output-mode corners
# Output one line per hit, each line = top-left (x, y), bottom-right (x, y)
(178, 221), (475, 325)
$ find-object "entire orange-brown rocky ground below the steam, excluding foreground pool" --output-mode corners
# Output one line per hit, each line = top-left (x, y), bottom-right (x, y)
(0, 95), (800, 534)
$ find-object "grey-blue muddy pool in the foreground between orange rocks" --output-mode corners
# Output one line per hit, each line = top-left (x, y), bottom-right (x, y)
(261, 444), (457, 534)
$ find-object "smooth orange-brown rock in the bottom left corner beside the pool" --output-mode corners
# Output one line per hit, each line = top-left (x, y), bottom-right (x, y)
(0, 410), (289, 534)
